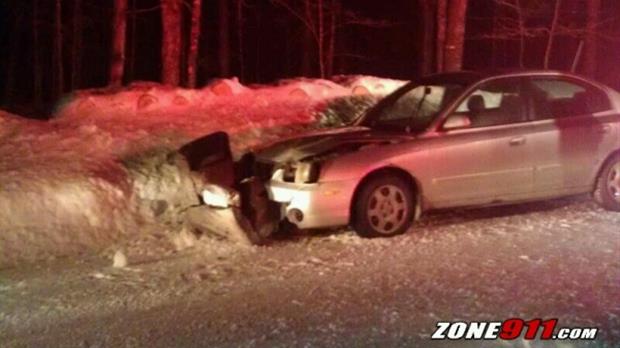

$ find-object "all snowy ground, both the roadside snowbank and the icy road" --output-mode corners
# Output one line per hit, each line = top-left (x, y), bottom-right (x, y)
(0, 78), (620, 348)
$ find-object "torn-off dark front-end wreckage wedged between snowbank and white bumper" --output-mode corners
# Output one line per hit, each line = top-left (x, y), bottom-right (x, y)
(179, 132), (282, 245)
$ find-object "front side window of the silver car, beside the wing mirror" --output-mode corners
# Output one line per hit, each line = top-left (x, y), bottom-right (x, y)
(456, 78), (527, 128)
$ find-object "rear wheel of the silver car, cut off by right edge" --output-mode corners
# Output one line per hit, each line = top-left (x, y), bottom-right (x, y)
(594, 154), (620, 212)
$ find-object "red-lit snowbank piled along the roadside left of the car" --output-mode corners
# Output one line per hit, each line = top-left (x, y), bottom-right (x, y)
(0, 76), (403, 267)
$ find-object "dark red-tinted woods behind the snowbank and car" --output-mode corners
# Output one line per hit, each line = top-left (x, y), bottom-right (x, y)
(0, 0), (620, 117)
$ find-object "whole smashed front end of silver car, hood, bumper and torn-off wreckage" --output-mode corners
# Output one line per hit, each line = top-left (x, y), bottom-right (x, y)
(181, 127), (398, 243)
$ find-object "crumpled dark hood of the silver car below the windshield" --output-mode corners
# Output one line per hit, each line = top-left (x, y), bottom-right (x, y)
(256, 127), (411, 163)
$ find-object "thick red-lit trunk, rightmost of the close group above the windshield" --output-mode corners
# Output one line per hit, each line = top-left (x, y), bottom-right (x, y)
(444, 0), (467, 71)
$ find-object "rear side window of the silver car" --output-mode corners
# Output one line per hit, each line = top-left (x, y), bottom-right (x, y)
(530, 78), (611, 120)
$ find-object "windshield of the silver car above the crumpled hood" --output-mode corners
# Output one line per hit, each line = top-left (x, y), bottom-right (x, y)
(360, 83), (464, 132)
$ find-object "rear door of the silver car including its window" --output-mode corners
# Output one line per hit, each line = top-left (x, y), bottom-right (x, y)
(527, 76), (614, 196)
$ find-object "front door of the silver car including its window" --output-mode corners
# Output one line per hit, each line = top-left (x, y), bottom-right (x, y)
(426, 77), (533, 207)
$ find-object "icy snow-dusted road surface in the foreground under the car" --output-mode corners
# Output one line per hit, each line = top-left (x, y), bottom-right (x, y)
(0, 198), (620, 347)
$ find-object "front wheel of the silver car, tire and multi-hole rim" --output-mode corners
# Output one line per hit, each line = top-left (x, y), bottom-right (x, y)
(351, 174), (416, 238)
